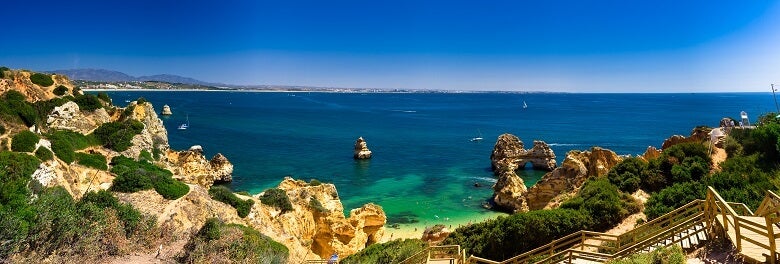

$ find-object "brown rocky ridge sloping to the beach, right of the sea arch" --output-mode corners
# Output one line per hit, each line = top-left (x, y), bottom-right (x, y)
(493, 147), (623, 212)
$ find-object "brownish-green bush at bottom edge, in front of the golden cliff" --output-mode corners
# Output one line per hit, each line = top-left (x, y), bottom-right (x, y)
(178, 218), (290, 264)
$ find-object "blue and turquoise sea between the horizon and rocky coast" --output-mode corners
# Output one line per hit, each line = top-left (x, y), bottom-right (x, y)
(102, 91), (774, 226)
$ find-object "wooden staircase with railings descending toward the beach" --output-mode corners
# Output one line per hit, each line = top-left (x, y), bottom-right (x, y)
(401, 187), (780, 264)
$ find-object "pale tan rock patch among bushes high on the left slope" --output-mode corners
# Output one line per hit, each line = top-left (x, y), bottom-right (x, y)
(46, 102), (111, 135)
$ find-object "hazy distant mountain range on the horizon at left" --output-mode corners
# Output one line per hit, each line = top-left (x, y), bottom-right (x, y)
(49, 69), (219, 86)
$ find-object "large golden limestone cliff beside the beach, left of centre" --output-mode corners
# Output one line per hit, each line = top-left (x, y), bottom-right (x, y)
(118, 178), (386, 263)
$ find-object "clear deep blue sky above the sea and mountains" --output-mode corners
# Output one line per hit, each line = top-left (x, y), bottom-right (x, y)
(0, 0), (780, 92)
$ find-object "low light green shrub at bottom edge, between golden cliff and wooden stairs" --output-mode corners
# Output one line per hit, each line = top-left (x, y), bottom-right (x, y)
(339, 239), (428, 264)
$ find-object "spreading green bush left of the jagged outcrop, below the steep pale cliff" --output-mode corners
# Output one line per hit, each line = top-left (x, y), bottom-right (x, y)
(111, 156), (190, 200)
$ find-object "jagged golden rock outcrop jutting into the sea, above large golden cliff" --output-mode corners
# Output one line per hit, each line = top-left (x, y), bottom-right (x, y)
(164, 145), (233, 188)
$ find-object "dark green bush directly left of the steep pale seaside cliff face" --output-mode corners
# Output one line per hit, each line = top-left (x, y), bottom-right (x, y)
(92, 119), (144, 152)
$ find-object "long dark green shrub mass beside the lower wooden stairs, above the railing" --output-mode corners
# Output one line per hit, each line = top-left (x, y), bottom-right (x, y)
(443, 209), (592, 260)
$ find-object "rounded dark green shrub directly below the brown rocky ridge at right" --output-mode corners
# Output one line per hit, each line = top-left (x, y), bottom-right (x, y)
(561, 178), (640, 231)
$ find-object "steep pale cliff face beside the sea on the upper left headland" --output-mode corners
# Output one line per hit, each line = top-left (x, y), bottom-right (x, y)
(121, 101), (169, 159)
